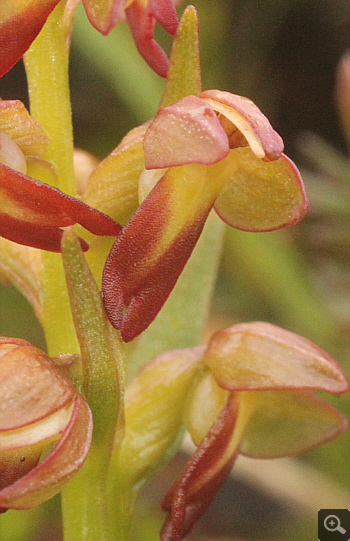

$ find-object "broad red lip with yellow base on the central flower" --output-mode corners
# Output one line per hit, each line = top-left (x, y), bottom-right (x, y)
(102, 165), (216, 342)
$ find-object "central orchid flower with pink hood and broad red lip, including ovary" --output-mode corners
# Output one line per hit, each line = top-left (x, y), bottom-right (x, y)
(96, 8), (308, 341)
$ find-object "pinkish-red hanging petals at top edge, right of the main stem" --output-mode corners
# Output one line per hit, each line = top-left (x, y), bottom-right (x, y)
(125, 0), (178, 77)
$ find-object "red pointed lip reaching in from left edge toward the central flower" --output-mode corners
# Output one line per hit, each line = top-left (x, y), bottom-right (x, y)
(0, 163), (121, 252)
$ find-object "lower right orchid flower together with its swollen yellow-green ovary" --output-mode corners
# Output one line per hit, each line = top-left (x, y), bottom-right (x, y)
(114, 322), (348, 541)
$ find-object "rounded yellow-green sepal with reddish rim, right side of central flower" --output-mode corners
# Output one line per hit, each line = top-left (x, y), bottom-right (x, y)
(214, 148), (308, 231)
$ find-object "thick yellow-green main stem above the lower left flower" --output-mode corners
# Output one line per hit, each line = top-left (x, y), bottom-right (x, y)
(25, 0), (79, 356)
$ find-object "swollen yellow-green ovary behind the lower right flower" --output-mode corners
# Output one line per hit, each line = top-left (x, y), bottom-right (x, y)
(112, 346), (204, 490)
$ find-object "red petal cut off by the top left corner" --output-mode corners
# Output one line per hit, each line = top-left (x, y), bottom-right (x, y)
(0, 0), (59, 77)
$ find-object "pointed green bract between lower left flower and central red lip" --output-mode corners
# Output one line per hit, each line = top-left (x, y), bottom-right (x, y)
(62, 228), (124, 446)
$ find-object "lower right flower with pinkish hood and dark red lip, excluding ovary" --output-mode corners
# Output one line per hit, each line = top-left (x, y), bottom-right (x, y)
(161, 323), (348, 541)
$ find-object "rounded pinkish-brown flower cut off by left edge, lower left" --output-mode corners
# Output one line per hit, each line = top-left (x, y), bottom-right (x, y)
(0, 338), (92, 512)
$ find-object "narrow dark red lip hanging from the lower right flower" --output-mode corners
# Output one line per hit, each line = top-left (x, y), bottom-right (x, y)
(161, 395), (239, 541)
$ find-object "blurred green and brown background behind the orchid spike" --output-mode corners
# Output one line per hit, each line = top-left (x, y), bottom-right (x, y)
(0, 0), (350, 541)
